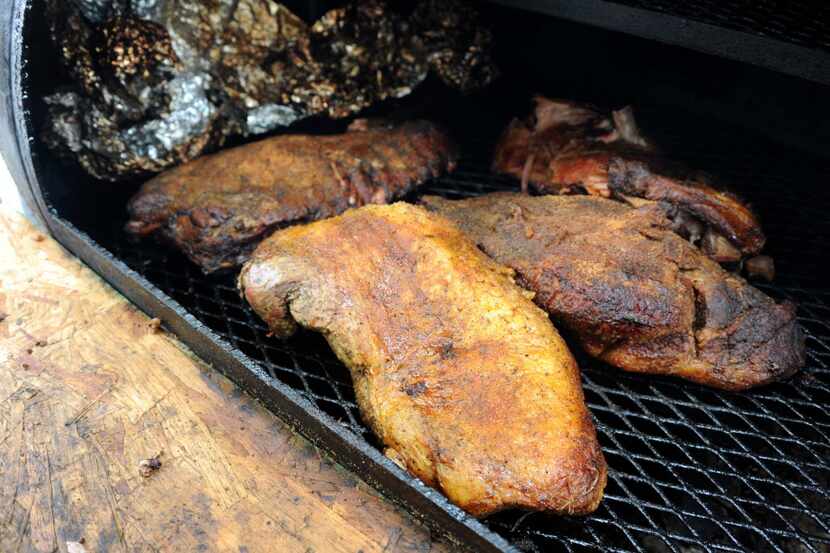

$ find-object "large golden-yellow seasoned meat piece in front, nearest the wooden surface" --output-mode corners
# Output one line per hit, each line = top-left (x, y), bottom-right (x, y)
(239, 203), (606, 516)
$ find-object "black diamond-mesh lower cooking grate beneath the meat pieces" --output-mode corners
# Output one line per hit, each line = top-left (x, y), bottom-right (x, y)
(57, 88), (830, 553)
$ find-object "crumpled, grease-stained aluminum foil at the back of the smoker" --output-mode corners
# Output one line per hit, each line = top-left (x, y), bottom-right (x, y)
(43, 0), (496, 181)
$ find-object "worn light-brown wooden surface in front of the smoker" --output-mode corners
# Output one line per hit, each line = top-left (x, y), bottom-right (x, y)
(0, 212), (449, 553)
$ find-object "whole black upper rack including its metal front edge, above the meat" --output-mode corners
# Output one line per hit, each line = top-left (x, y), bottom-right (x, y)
(491, 0), (830, 84)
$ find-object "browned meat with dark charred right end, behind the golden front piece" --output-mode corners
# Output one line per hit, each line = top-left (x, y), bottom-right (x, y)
(423, 193), (804, 390)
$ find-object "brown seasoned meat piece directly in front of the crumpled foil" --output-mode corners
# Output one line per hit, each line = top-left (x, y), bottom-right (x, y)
(127, 119), (456, 272)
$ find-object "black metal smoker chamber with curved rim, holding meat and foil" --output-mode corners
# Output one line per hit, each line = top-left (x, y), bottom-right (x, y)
(0, 0), (830, 553)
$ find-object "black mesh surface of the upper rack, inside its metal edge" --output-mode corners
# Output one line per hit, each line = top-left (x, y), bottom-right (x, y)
(611, 0), (830, 50)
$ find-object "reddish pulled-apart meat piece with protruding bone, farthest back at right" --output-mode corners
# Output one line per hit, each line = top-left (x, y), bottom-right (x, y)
(493, 97), (765, 262)
